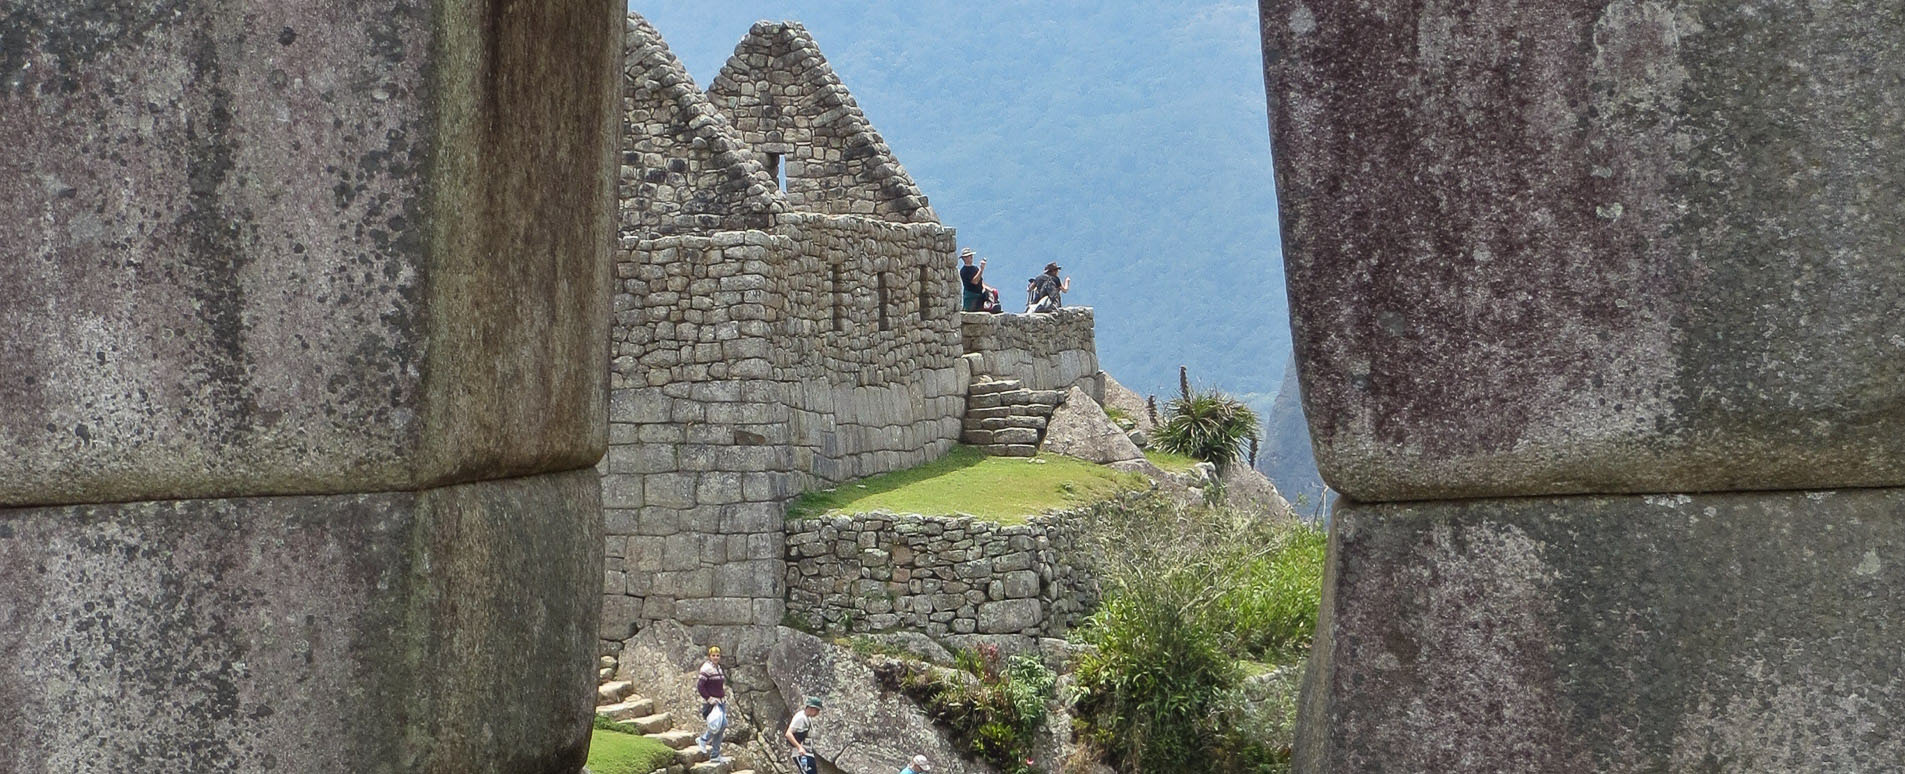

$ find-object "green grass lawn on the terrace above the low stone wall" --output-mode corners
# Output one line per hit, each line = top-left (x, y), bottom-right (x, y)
(787, 446), (1151, 524)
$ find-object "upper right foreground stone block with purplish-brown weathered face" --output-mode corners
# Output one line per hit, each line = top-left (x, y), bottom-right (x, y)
(1261, 0), (1905, 499)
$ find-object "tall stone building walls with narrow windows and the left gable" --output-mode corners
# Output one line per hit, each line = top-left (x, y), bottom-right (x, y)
(600, 15), (964, 662)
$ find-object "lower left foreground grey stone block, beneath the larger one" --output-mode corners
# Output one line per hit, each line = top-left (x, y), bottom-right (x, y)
(0, 471), (602, 774)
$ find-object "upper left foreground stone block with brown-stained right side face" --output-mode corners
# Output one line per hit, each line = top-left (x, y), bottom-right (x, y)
(0, 0), (623, 505)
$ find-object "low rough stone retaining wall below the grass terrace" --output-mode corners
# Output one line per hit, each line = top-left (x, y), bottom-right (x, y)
(787, 513), (1099, 648)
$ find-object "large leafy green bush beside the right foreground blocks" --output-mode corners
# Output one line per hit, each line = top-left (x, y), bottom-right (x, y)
(1076, 498), (1324, 772)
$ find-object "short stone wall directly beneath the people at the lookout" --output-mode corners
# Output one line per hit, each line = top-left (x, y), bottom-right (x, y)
(960, 307), (1105, 402)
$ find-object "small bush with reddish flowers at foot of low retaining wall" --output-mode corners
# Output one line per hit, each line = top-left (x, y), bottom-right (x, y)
(874, 644), (1057, 774)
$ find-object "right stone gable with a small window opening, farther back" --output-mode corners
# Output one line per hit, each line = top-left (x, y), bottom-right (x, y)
(707, 21), (939, 223)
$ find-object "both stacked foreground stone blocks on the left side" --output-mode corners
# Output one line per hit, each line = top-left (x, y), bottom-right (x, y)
(0, 0), (621, 774)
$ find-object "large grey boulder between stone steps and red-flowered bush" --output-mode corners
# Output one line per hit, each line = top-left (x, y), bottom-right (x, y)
(768, 627), (989, 774)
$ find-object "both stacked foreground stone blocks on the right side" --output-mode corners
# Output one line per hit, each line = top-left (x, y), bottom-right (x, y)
(1261, 0), (1905, 774)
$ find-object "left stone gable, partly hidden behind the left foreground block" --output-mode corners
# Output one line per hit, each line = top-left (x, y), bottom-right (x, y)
(619, 13), (787, 238)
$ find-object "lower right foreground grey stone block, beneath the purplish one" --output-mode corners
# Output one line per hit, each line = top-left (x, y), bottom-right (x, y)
(1297, 488), (1905, 774)
